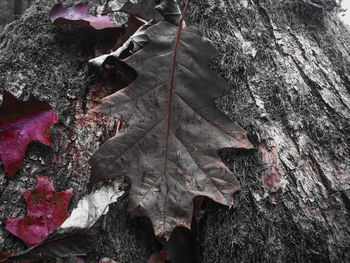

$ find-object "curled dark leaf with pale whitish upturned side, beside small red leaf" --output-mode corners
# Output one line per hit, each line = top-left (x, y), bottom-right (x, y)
(11, 181), (124, 262)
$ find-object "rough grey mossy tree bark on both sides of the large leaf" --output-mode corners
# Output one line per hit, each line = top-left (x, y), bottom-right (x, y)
(0, 0), (350, 263)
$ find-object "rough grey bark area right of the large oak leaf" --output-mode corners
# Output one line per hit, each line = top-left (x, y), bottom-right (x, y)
(189, 0), (350, 262)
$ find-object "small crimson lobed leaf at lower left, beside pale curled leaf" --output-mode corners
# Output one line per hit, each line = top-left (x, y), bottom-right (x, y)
(5, 176), (72, 247)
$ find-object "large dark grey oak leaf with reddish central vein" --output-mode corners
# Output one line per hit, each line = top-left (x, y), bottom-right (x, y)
(90, 18), (252, 238)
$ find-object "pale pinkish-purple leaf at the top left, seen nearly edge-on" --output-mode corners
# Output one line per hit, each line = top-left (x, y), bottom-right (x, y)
(50, 3), (120, 30)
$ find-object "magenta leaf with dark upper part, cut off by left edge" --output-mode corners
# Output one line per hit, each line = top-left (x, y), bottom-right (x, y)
(0, 91), (57, 175)
